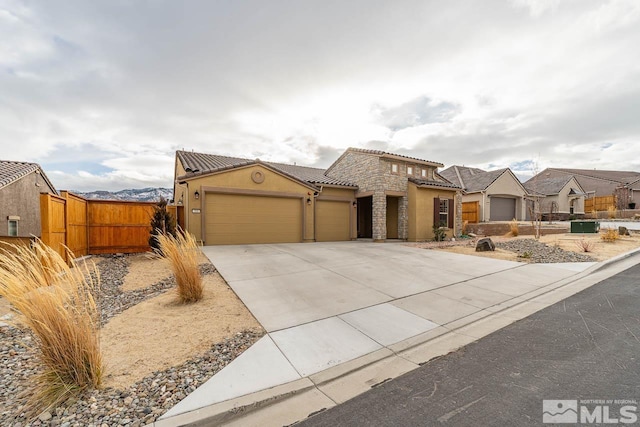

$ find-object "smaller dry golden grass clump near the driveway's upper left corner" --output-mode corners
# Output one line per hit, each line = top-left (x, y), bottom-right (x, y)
(157, 232), (204, 303)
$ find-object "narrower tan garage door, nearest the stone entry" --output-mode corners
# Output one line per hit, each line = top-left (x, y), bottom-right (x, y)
(316, 200), (353, 242)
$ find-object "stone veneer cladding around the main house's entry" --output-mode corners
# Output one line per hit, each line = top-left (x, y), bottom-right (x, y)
(327, 151), (440, 241)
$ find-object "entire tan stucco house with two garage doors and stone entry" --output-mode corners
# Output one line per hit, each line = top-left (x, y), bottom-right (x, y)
(174, 148), (461, 245)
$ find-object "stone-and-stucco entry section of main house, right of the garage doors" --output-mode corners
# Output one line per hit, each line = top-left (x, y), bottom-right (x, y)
(326, 148), (462, 241)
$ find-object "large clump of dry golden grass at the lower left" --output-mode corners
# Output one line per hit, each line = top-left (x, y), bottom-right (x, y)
(0, 240), (103, 409)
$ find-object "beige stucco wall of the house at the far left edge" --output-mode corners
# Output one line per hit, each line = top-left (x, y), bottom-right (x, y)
(0, 172), (51, 237)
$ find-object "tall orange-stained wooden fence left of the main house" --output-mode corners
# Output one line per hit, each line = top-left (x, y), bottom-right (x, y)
(40, 191), (160, 259)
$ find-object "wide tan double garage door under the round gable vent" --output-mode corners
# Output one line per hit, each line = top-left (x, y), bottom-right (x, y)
(204, 193), (302, 245)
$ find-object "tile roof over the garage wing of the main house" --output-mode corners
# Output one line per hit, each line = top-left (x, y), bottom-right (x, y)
(176, 151), (357, 188)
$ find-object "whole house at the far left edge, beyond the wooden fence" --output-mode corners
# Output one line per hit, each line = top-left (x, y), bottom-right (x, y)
(0, 160), (57, 238)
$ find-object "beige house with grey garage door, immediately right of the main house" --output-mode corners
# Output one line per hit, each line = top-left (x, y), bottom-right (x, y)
(440, 166), (528, 222)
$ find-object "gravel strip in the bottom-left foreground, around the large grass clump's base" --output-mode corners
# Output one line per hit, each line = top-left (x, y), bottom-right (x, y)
(0, 326), (262, 427)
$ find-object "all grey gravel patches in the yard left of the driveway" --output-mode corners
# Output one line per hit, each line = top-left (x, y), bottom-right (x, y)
(0, 255), (262, 427)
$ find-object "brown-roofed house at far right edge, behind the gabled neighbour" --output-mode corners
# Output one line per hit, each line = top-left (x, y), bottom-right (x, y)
(532, 168), (640, 209)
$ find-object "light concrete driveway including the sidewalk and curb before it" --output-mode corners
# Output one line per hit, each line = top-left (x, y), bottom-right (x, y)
(155, 242), (636, 426)
